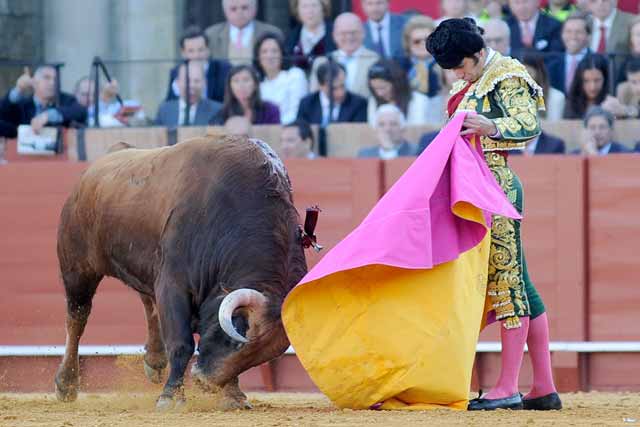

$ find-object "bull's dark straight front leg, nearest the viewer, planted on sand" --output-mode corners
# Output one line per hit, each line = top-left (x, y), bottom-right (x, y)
(156, 282), (195, 410)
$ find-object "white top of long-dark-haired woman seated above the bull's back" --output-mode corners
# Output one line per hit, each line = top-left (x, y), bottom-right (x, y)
(260, 67), (309, 124)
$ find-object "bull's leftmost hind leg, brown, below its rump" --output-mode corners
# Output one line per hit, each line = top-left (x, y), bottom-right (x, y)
(55, 272), (102, 402)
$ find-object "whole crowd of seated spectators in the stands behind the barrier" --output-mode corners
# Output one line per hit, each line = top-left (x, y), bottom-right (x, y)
(0, 0), (640, 158)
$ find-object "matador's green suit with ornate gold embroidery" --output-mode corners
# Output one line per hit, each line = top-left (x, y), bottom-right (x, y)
(451, 51), (545, 329)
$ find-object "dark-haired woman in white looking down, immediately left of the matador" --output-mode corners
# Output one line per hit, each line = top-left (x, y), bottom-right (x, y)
(367, 59), (444, 126)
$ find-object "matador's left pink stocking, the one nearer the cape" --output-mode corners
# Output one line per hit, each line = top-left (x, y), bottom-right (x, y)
(482, 317), (529, 399)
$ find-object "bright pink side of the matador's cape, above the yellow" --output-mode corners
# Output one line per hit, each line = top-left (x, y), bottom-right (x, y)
(300, 113), (521, 284)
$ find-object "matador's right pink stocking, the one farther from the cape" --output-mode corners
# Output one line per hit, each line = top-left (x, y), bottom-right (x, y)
(525, 313), (556, 399)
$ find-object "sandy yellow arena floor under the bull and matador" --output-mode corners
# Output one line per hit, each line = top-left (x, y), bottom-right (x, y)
(0, 393), (640, 427)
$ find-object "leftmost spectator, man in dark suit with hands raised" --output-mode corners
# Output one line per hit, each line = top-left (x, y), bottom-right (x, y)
(0, 65), (87, 138)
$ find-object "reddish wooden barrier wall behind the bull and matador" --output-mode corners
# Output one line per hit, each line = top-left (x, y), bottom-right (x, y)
(0, 132), (640, 390)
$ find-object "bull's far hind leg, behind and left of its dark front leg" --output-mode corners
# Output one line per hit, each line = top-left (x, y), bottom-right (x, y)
(140, 294), (167, 384)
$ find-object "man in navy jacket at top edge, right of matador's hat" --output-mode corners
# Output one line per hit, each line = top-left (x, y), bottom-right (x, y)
(507, 0), (562, 57)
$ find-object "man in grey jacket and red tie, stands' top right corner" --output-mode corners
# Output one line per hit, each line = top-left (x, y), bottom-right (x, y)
(588, 0), (634, 59)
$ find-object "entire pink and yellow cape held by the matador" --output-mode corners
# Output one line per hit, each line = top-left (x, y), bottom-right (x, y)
(282, 113), (520, 409)
